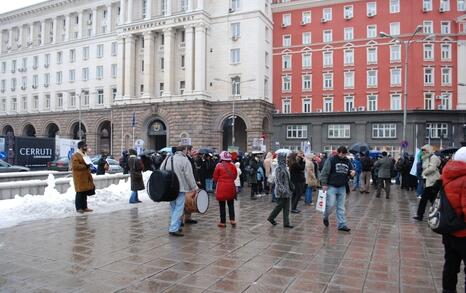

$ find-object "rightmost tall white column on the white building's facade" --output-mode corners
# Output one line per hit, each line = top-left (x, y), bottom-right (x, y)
(194, 23), (206, 93)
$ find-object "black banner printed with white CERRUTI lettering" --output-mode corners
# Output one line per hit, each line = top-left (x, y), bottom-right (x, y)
(15, 137), (55, 169)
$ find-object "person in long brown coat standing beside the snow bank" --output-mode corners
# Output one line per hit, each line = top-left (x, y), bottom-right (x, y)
(71, 140), (95, 214)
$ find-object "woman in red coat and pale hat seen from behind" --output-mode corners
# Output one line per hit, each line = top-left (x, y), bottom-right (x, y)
(213, 151), (237, 228)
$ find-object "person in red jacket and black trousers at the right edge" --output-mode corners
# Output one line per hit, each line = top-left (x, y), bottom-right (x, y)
(442, 147), (466, 293)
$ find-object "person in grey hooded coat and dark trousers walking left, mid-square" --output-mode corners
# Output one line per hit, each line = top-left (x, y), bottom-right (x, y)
(267, 153), (294, 228)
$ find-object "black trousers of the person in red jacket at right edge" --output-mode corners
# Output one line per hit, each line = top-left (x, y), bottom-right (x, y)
(442, 235), (466, 293)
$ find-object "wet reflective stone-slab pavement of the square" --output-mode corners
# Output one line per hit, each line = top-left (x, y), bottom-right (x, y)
(0, 187), (464, 293)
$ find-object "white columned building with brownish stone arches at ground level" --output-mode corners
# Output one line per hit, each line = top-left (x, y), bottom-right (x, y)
(0, 0), (273, 154)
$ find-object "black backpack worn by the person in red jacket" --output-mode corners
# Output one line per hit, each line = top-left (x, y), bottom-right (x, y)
(427, 181), (466, 235)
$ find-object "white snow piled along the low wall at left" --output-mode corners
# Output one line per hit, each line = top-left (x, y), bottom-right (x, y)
(0, 171), (160, 229)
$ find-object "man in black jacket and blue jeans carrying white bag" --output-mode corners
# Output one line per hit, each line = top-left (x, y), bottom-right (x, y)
(320, 146), (356, 232)
